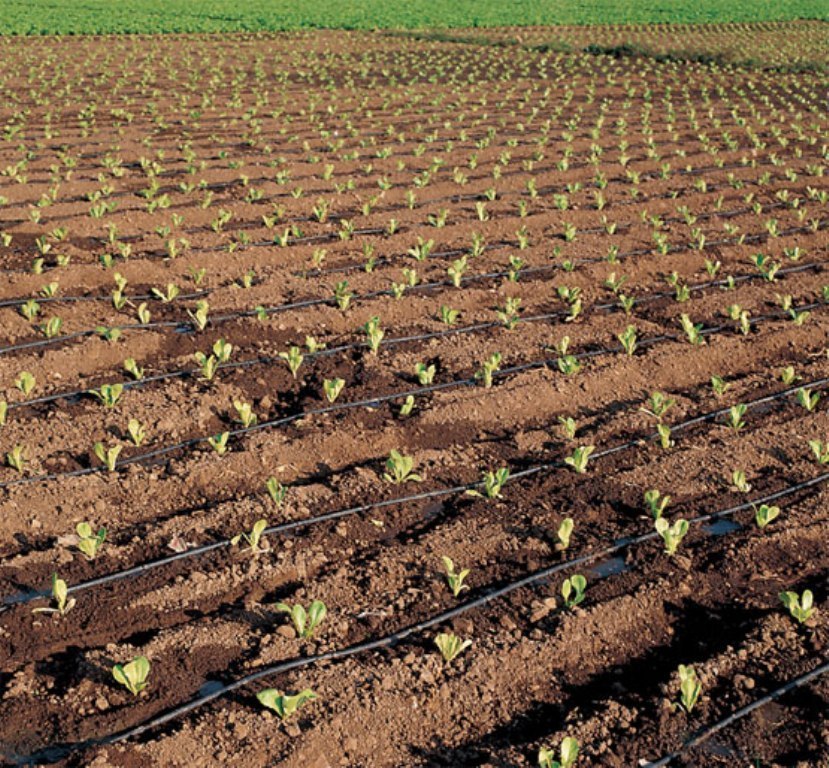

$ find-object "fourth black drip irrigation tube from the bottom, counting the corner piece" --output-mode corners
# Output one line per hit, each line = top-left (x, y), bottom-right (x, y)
(0, 302), (824, 490)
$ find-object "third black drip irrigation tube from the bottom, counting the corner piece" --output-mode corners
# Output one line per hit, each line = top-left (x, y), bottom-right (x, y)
(0, 378), (829, 613)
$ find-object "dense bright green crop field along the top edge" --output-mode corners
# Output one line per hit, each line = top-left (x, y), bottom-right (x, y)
(0, 0), (829, 35)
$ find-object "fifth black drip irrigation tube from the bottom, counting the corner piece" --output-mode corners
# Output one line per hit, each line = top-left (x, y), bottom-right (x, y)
(8, 262), (823, 411)
